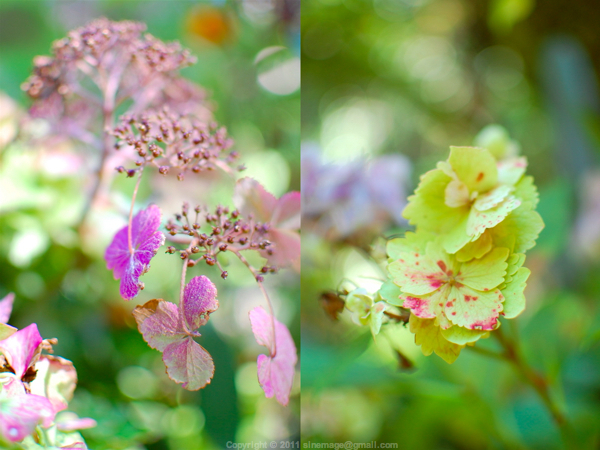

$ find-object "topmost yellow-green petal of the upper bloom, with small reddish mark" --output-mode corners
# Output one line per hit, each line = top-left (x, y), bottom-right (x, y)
(448, 147), (498, 193)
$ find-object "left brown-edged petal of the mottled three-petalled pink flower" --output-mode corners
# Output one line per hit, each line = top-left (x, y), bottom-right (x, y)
(133, 299), (185, 352)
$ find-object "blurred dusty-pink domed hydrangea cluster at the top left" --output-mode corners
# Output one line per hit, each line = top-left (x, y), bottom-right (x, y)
(22, 18), (204, 135)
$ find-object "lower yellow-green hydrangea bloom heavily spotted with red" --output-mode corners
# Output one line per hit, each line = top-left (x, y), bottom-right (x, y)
(387, 231), (529, 362)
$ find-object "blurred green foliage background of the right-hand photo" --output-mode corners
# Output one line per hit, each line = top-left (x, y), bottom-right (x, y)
(302, 0), (600, 449)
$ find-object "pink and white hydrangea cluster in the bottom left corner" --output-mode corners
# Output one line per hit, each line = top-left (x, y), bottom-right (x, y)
(0, 294), (96, 450)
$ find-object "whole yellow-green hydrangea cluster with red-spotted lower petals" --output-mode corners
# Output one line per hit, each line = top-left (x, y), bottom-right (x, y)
(381, 133), (543, 363)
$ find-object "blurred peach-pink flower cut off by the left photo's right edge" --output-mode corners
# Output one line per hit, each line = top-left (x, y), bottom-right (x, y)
(234, 177), (300, 269)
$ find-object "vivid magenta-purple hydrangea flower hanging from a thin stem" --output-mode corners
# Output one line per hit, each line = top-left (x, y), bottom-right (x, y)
(104, 205), (165, 300)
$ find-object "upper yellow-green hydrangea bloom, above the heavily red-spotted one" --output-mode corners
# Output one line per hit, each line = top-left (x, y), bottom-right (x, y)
(403, 147), (537, 257)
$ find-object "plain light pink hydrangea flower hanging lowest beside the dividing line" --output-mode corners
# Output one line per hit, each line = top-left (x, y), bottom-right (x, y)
(250, 306), (298, 406)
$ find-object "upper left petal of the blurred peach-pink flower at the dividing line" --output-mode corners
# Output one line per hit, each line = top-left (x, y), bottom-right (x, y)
(233, 177), (278, 222)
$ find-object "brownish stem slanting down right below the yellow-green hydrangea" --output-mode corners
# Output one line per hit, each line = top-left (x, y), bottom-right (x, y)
(492, 328), (577, 449)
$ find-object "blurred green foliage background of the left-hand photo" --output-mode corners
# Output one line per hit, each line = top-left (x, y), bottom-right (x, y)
(0, 1), (300, 450)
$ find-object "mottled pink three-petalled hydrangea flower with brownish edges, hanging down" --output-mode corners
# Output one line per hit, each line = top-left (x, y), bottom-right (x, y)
(133, 276), (219, 391)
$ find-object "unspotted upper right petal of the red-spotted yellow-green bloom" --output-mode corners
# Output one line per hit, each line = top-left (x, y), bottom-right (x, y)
(456, 247), (508, 291)
